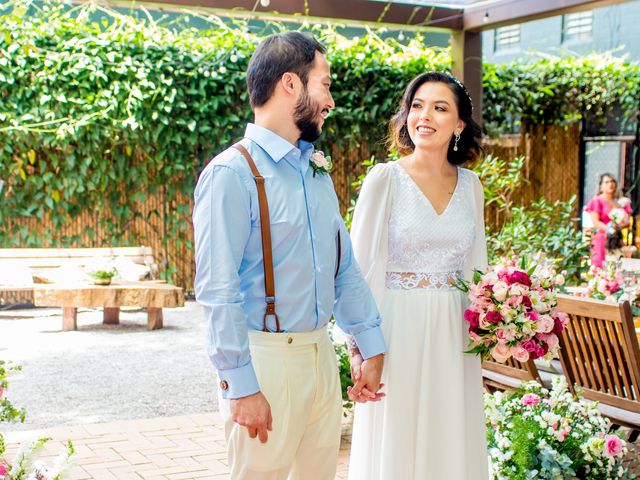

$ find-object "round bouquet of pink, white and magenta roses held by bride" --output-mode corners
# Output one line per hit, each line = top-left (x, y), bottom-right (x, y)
(458, 260), (568, 362)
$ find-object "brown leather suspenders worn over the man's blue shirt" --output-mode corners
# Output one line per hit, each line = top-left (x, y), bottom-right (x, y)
(233, 143), (342, 332)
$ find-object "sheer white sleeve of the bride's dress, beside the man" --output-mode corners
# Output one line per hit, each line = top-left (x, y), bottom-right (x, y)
(351, 163), (392, 308)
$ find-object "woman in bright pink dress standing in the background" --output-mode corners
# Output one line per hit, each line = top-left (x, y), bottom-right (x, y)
(585, 173), (631, 268)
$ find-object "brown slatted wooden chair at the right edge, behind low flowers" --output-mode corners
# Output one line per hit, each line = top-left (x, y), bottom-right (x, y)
(558, 295), (640, 437)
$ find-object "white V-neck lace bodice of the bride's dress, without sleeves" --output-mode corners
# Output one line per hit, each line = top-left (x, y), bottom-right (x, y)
(386, 162), (476, 288)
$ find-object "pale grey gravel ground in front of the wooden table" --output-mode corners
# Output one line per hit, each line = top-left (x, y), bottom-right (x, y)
(0, 302), (217, 431)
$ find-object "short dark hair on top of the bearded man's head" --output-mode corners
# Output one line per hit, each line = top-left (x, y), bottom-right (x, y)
(247, 32), (325, 108)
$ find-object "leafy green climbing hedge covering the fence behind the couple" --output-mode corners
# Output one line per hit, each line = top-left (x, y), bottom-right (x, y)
(0, 3), (639, 266)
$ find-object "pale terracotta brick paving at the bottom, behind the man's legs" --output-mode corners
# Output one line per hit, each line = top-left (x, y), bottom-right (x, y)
(5, 413), (349, 480)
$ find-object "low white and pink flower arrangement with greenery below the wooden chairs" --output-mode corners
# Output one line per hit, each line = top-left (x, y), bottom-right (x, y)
(484, 377), (635, 480)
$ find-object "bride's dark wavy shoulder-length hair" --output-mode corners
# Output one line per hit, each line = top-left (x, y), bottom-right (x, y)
(388, 72), (482, 165)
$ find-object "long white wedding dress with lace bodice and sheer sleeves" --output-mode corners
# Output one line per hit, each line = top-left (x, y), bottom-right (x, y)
(349, 162), (488, 480)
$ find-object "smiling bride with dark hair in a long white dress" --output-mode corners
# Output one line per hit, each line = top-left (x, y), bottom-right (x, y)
(349, 72), (488, 480)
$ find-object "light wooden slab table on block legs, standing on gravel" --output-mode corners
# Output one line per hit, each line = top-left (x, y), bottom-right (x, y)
(33, 282), (184, 331)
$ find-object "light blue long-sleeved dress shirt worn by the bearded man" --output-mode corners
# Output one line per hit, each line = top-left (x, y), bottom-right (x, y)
(193, 124), (385, 398)
